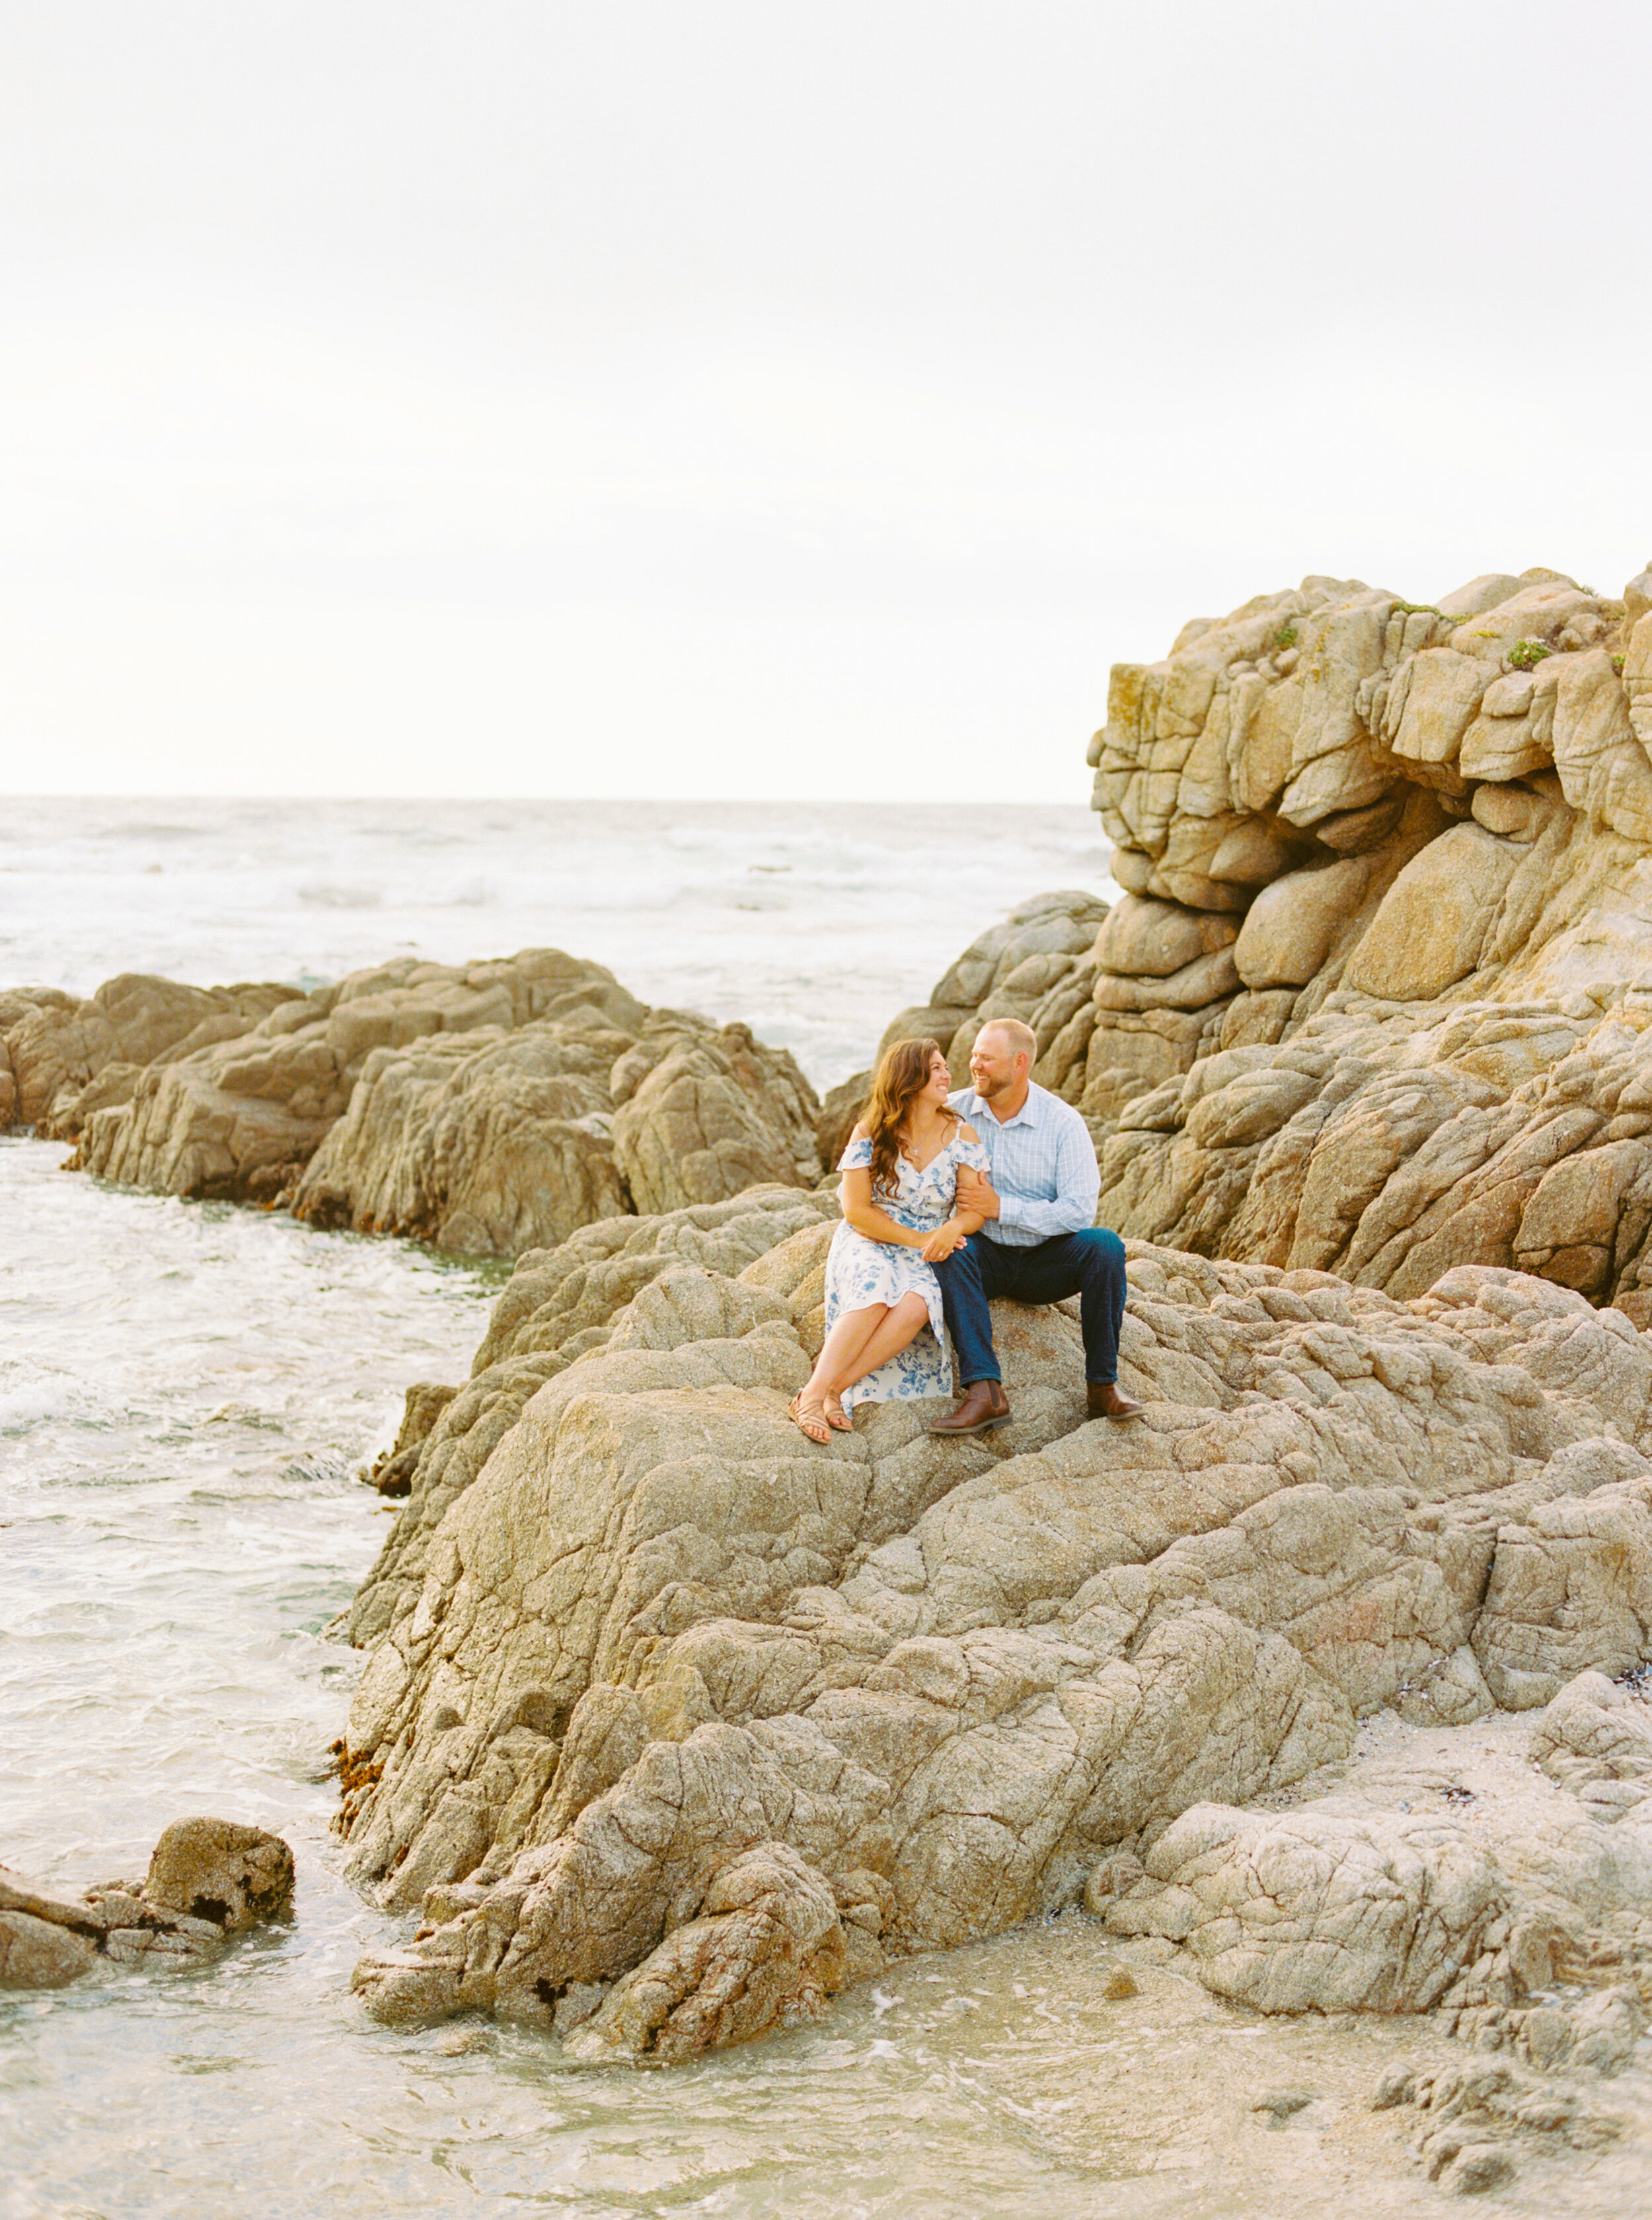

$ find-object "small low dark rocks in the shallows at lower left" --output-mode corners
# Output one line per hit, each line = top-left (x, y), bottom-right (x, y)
(0, 1818), (293, 1989)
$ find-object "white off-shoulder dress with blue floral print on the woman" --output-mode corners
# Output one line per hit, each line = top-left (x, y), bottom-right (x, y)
(826, 1126), (988, 1410)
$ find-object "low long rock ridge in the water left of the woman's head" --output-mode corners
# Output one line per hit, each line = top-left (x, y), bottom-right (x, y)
(0, 948), (819, 1257)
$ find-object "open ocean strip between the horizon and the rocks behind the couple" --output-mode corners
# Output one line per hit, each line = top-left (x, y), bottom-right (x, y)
(0, 799), (1110, 1090)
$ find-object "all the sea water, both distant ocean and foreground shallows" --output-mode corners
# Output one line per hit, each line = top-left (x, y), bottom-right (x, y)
(0, 799), (1643, 2220)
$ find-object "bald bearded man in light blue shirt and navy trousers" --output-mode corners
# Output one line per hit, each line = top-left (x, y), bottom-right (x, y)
(930, 1017), (1141, 1434)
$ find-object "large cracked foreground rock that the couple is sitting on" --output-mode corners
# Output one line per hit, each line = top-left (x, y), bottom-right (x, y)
(342, 1214), (1652, 2058)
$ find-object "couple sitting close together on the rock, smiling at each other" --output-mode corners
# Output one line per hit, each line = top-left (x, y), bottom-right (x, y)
(793, 1017), (1141, 1441)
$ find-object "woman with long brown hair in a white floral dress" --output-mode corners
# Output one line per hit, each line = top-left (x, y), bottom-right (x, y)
(790, 1041), (988, 1441)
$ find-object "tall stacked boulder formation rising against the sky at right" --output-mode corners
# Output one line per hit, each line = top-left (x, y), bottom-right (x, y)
(1070, 571), (1652, 1323)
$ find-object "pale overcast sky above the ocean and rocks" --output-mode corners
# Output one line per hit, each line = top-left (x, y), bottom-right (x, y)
(0, 0), (1652, 810)
